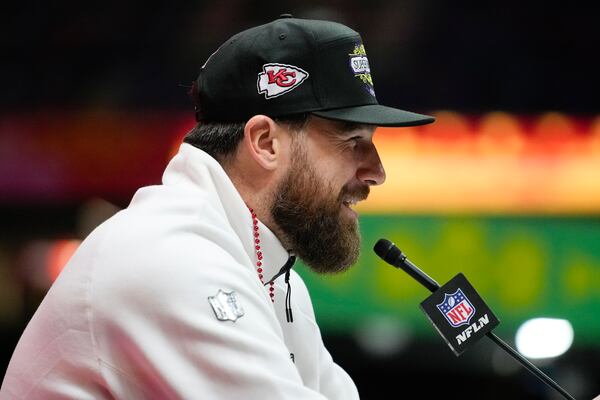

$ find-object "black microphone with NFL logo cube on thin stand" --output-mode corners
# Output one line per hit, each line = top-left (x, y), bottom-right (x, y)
(373, 239), (575, 400)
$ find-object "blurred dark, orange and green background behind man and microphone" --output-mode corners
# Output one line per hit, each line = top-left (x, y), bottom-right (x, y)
(0, 0), (600, 399)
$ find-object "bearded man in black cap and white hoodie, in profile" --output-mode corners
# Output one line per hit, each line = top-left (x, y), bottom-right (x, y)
(0, 15), (433, 400)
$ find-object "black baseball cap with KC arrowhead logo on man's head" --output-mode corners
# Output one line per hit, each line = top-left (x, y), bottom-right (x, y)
(192, 14), (434, 126)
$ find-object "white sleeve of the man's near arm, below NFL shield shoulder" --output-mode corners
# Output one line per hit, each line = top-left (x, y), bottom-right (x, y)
(90, 235), (325, 400)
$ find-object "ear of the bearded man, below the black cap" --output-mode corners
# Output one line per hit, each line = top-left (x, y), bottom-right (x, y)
(244, 115), (289, 170)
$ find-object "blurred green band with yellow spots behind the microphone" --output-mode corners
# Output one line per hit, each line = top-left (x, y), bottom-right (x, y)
(297, 215), (600, 346)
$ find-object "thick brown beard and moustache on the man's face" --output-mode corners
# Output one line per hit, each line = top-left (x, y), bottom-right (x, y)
(271, 146), (369, 273)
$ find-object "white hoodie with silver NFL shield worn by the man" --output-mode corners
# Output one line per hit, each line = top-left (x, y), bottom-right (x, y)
(0, 144), (358, 400)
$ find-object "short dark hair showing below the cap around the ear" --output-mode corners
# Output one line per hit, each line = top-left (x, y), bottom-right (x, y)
(183, 114), (308, 162)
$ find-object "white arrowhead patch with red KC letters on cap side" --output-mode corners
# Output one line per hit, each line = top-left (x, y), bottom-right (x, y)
(256, 63), (308, 99)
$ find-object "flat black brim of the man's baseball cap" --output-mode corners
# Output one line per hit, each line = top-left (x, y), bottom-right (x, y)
(311, 104), (435, 126)
